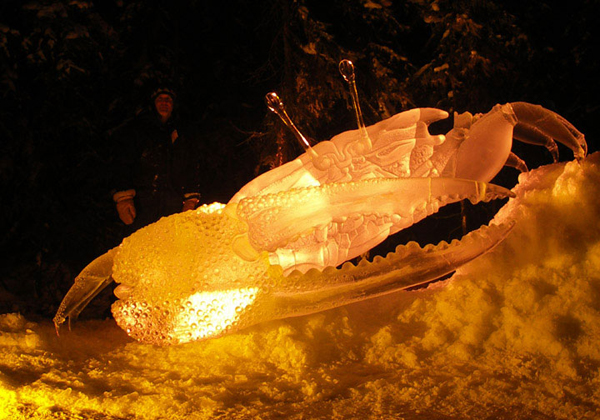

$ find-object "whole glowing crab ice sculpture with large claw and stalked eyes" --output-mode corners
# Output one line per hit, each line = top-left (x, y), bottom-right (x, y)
(54, 61), (587, 344)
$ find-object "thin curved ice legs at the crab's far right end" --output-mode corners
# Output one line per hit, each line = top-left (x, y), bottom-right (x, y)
(511, 102), (587, 162)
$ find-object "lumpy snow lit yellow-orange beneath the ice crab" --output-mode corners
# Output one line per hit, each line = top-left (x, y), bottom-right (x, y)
(0, 153), (600, 419)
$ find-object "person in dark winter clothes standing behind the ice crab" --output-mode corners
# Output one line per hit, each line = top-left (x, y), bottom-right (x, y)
(112, 88), (200, 233)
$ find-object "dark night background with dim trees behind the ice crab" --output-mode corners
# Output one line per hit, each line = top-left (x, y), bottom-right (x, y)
(0, 0), (600, 317)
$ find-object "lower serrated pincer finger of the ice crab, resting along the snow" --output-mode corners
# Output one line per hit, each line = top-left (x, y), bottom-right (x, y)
(265, 222), (515, 316)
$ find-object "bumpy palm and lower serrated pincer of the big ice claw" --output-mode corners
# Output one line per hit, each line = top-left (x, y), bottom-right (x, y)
(113, 206), (512, 345)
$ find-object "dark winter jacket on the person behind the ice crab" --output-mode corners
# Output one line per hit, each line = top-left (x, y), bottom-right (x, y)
(113, 113), (201, 228)
